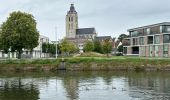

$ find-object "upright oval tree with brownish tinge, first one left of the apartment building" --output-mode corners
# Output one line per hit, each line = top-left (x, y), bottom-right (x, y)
(103, 39), (112, 56)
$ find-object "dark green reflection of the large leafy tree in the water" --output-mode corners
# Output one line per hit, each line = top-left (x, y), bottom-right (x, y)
(0, 78), (39, 100)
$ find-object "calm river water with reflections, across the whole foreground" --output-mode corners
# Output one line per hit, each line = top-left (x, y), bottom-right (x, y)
(0, 72), (170, 100)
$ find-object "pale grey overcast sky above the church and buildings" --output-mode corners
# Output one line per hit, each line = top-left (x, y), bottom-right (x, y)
(0, 0), (170, 40)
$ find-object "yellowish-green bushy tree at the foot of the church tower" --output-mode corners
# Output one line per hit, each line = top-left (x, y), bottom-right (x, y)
(60, 39), (77, 55)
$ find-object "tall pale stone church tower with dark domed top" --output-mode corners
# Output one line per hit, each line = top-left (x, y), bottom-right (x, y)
(66, 4), (78, 38)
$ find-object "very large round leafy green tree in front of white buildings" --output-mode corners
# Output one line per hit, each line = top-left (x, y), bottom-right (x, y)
(0, 11), (39, 59)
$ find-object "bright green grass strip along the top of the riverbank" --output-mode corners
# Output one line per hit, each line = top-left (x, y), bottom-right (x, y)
(0, 56), (170, 65)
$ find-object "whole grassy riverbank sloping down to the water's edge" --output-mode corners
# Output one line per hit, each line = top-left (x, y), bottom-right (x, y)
(0, 57), (170, 71)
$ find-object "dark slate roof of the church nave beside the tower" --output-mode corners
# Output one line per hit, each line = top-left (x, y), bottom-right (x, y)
(76, 28), (96, 35)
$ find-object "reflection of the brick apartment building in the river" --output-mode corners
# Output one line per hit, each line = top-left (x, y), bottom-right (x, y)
(128, 73), (170, 100)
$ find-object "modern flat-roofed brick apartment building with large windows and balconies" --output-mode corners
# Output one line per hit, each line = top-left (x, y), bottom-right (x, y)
(123, 22), (170, 57)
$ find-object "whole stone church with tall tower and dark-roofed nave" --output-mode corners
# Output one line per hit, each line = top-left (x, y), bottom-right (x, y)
(66, 4), (97, 52)
